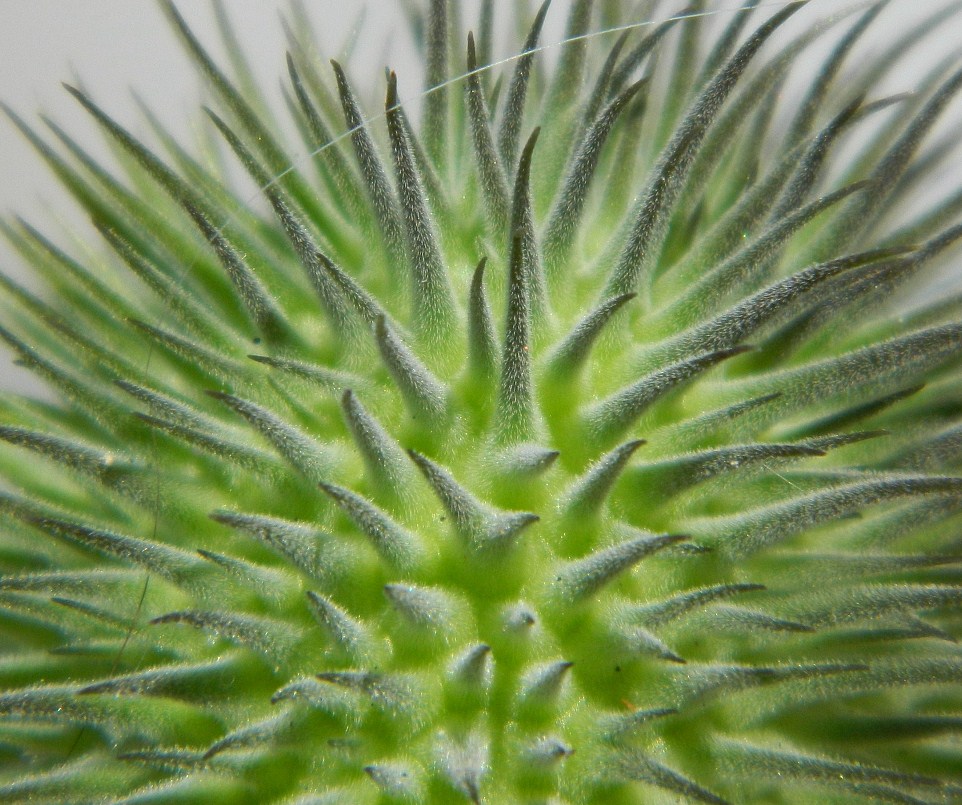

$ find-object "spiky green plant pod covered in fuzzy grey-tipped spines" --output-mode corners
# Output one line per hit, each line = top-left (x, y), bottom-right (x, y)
(0, 0), (962, 805)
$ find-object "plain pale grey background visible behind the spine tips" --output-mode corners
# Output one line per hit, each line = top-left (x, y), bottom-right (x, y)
(0, 0), (962, 396)
